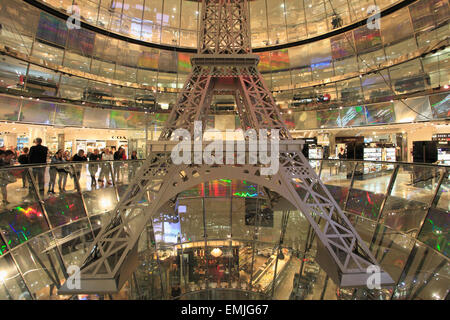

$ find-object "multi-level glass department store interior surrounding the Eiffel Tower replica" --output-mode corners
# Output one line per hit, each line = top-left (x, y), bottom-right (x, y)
(0, 0), (450, 300)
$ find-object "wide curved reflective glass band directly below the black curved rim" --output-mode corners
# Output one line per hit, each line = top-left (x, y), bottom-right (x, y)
(0, 0), (450, 109)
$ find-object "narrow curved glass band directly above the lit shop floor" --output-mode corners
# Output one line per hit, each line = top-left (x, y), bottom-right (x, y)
(0, 93), (450, 134)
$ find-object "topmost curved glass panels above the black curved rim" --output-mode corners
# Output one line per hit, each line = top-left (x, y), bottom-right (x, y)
(40, 0), (401, 48)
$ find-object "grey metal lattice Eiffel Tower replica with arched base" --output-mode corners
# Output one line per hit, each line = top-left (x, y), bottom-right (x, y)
(59, 0), (393, 294)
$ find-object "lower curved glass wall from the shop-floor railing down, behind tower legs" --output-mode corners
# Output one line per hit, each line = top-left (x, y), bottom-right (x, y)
(0, 160), (450, 300)
